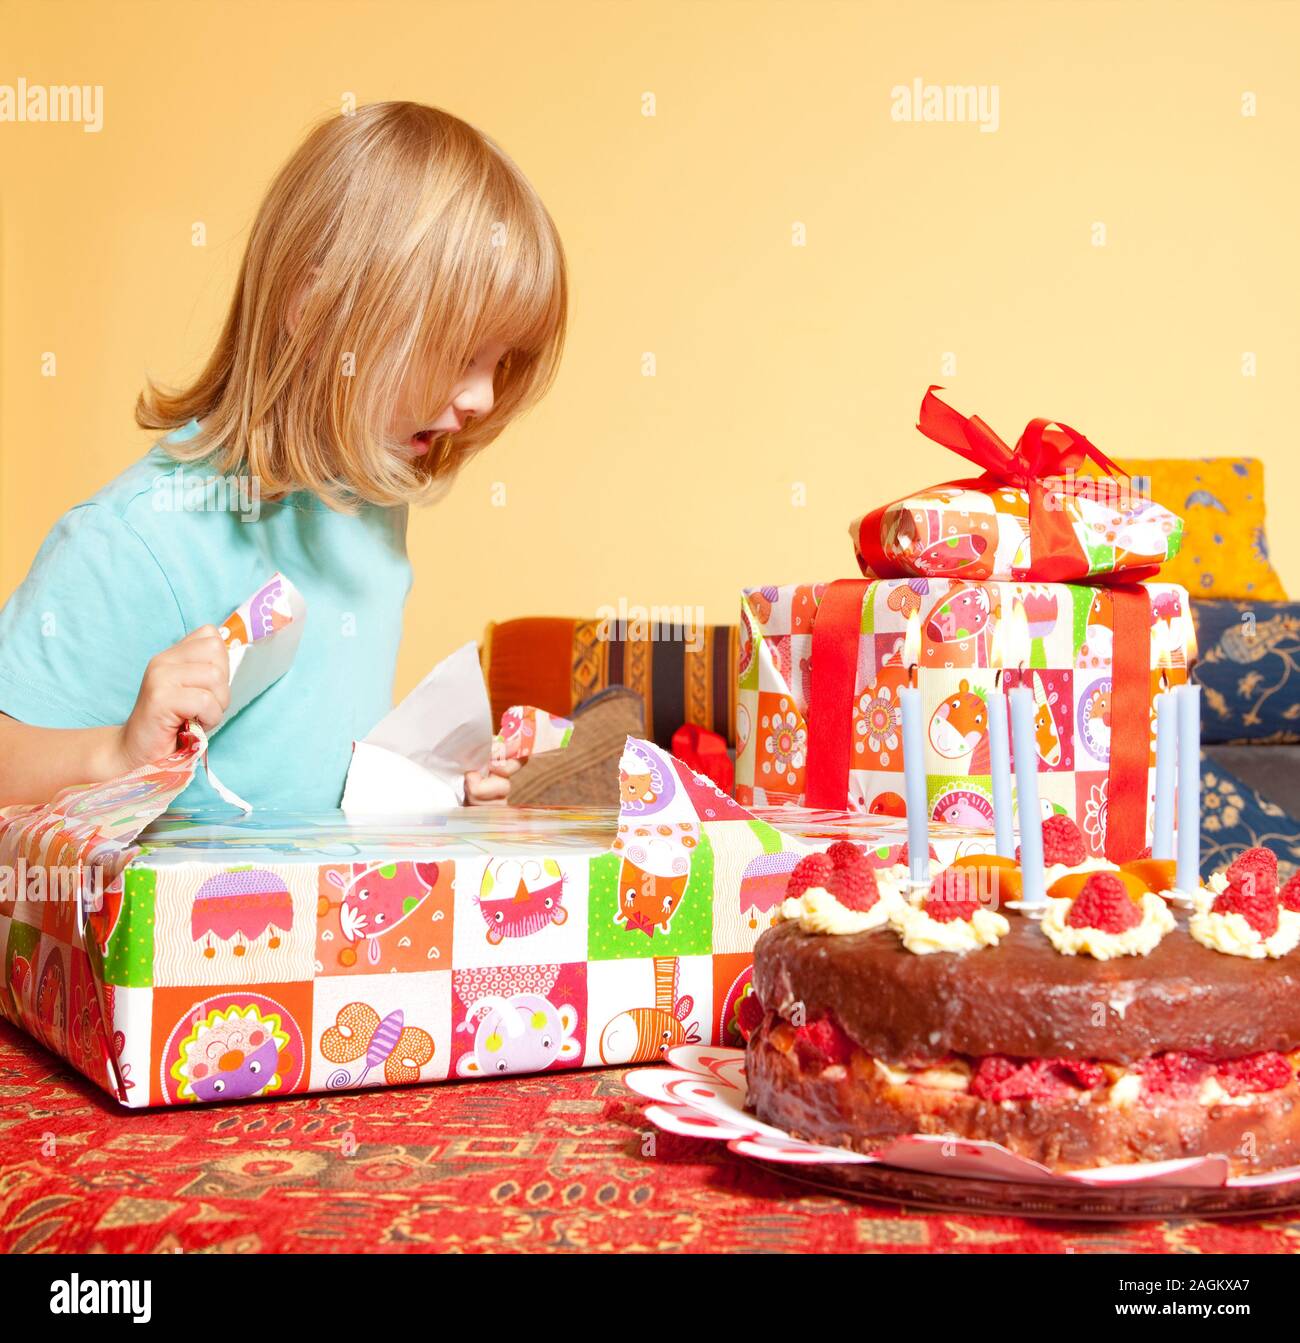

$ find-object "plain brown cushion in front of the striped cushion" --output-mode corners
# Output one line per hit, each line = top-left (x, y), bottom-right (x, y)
(510, 686), (645, 807)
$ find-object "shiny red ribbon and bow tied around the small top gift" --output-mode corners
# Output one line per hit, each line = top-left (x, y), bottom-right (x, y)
(857, 387), (1156, 583)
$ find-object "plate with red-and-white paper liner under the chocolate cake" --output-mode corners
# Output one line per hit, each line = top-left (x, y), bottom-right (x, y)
(623, 1045), (1300, 1221)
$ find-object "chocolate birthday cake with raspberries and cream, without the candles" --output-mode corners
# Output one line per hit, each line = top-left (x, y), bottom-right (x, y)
(743, 817), (1300, 1172)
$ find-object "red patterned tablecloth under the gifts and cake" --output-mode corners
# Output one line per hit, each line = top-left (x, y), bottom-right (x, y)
(0, 1023), (1300, 1254)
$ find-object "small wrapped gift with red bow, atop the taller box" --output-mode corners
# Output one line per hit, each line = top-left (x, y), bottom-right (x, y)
(850, 387), (1183, 583)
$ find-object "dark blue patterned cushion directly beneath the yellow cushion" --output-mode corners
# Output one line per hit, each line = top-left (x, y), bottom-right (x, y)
(1191, 602), (1300, 743)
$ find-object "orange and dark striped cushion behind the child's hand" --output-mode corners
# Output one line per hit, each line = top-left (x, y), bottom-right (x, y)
(481, 616), (739, 747)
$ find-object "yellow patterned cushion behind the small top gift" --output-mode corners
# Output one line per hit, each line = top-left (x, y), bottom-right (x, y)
(1120, 457), (1287, 602)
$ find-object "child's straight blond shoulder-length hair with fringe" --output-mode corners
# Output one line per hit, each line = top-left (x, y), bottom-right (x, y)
(136, 102), (568, 508)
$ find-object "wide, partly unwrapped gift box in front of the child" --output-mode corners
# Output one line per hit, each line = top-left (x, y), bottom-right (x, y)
(0, 739), (988, 1107)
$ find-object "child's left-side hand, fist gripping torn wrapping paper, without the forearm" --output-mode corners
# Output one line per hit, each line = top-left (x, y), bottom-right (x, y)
(115, 624), (230, 774)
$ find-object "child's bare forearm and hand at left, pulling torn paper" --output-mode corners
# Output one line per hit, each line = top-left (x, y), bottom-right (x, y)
(0, 624), (230, 806)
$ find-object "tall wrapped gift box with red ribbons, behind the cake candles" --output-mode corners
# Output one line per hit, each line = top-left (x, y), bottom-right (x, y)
(736, 577), (1195, 857)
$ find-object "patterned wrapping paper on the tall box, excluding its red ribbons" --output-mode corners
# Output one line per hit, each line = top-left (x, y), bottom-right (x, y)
(736, 577), (1195, 854)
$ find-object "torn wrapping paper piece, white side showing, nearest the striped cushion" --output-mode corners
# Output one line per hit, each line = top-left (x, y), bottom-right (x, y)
(342, 643), (573, 817)
